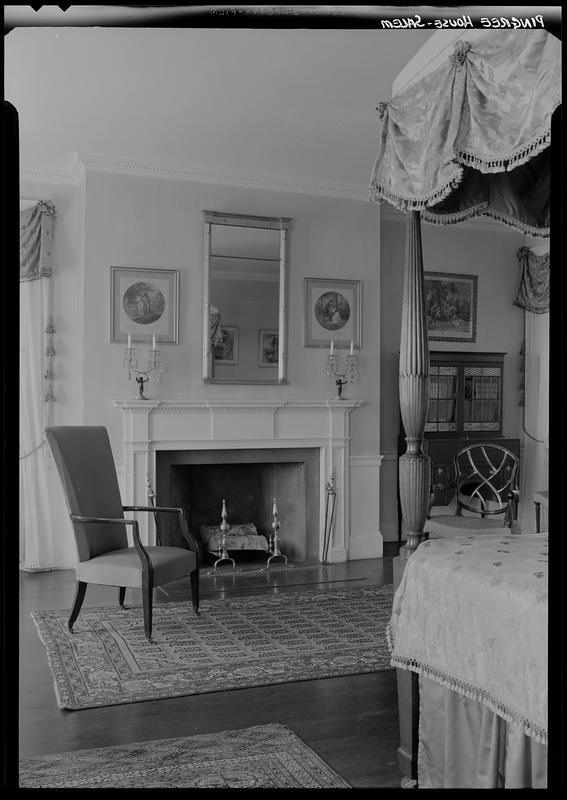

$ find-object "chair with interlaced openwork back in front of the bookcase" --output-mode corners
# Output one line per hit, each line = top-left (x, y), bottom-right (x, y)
(424, 443), (520, 538)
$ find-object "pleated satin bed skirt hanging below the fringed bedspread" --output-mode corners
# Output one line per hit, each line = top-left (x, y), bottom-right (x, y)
(417, 676), (547, 789)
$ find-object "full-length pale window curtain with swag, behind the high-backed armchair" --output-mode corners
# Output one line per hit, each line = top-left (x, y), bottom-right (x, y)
(19, 201), (55, 572)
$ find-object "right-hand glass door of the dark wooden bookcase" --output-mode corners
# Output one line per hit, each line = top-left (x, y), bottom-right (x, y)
(463, 367), (502, 433)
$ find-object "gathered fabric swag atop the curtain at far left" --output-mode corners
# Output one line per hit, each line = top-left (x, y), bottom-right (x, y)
(20, 200), (56, 281)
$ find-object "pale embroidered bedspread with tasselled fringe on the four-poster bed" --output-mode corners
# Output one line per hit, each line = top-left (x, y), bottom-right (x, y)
(387, 533), (548, 743)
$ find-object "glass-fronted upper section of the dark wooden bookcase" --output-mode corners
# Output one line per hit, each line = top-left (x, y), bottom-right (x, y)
(425, 351), (506, 438)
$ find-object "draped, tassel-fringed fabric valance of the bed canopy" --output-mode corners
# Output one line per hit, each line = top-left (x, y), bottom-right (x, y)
(370, 30), (561, 236)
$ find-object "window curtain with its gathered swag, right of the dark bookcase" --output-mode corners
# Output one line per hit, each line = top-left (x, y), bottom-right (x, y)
(514, 240), (549, 531)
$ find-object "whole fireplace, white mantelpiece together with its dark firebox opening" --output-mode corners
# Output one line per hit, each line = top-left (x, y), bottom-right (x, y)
(115, 399), (360, 562)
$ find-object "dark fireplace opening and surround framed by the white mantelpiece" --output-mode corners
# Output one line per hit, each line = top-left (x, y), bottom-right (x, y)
(156, 448), (320, 564)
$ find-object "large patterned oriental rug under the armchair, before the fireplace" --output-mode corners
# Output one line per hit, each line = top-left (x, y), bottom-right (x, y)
(32, 585), (393, 710)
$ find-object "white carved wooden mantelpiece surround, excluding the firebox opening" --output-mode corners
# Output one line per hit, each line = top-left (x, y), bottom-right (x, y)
(114, 400), (360, 562)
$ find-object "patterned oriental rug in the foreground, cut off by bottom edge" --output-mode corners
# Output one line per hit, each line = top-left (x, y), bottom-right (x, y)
(19, 724), (349, 789)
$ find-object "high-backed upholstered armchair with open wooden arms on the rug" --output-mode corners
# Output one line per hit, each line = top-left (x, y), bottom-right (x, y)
(45, 425), (201, 641)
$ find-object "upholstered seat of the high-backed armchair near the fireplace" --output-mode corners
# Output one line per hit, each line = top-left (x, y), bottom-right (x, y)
(76, 546), (197, 588)
